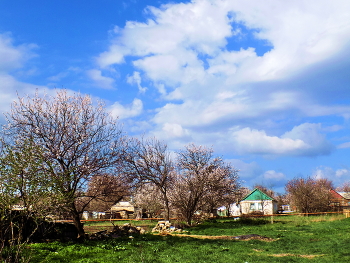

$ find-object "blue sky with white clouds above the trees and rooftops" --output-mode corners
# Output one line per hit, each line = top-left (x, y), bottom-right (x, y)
(0, 0), (350, 192)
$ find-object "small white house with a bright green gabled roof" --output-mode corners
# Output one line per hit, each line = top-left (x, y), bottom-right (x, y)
(240, 188), (278, 215)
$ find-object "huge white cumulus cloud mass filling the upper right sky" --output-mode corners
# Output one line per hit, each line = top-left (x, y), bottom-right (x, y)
(96, 0), (350, 156)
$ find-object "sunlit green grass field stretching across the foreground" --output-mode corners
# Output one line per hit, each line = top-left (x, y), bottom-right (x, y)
(31, 215), (350, 263)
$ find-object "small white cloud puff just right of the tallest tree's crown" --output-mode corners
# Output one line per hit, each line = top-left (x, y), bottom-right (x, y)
(108, 99), (143, 119)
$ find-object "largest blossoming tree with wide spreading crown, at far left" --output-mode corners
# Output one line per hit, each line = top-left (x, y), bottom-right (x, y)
(5, 90), (126, 238)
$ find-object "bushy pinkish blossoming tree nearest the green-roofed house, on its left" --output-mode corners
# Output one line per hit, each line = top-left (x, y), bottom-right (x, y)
(172, 144), (238, 225)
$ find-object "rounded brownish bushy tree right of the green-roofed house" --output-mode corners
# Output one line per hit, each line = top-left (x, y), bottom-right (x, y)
(286, 177), (333, 213)
